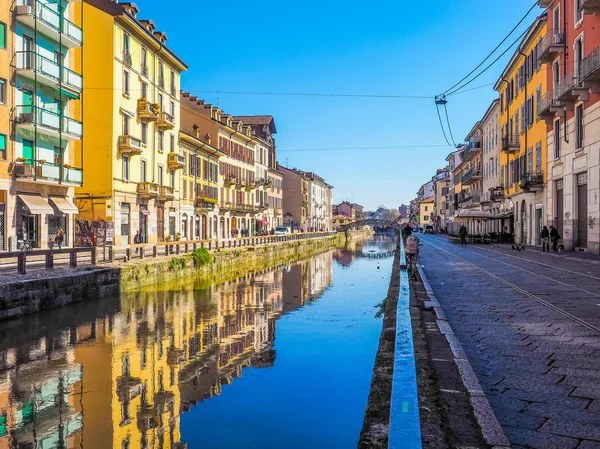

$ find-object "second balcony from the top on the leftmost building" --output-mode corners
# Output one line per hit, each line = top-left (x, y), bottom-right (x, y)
(15, 51), (83, 98)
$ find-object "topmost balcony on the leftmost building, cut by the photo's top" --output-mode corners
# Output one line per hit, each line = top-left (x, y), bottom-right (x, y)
(15, 0), (83, 48)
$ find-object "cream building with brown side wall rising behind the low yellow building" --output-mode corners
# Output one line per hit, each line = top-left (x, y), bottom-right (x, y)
(181, 92), (257, 239)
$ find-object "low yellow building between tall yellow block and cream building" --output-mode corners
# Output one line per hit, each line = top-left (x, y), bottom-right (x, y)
(179, 128), (225, 240)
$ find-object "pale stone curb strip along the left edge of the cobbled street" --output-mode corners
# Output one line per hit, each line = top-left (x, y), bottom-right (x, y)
(418, 266), (510, 449)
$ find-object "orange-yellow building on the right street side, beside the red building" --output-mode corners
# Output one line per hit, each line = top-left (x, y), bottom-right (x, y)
(495, 15), (547, 245)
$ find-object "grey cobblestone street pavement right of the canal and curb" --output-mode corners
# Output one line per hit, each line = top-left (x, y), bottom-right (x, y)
(419, 235), (600, 449)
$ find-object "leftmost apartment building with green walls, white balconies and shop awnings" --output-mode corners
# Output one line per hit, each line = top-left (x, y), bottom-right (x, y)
(0, 0), (83, 250)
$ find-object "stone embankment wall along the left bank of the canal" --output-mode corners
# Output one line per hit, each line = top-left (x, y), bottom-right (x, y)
(0, 231), (373, 321)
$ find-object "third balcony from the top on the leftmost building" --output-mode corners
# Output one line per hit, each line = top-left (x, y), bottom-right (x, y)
(15, 106), (83, 141)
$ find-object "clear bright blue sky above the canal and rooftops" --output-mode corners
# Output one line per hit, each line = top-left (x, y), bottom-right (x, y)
(137, 0), (542, 209)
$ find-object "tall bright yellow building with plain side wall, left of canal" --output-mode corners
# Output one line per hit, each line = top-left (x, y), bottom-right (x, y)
(76, 1), (187, 245)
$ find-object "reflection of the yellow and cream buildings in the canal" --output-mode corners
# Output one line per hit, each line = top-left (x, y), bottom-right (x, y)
(0, 253), (332, 449)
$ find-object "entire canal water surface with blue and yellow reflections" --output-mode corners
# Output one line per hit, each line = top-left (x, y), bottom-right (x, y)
(0, 236), (395, 449)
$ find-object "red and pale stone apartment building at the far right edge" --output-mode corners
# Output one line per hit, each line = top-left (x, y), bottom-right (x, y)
(537, 0), (600, 254)
